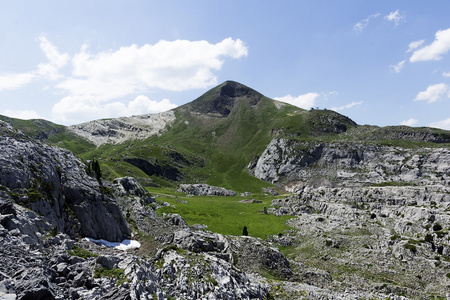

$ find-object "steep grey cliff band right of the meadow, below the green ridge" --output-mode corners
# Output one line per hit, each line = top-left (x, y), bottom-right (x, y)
(251, 139), (450, 190)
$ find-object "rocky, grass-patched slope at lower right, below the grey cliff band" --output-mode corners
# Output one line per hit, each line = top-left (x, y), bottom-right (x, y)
(269, 184), (450, 299)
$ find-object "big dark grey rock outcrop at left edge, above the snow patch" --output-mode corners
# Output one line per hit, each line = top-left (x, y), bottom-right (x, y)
(0, 122), (130, 241)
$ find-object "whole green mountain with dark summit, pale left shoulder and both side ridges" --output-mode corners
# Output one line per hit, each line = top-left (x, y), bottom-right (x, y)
(4, 81), (450, 191)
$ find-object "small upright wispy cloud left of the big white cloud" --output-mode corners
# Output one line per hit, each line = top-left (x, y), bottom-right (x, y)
(36, 35), (70, 80)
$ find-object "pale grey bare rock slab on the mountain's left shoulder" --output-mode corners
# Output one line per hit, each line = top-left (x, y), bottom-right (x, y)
(67, 110), (176, 146)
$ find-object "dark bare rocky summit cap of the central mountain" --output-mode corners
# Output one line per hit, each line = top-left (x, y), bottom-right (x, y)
(184, 80), (263, 117)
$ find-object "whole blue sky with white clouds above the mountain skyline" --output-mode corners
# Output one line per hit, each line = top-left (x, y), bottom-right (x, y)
(0, 0), (450, 130)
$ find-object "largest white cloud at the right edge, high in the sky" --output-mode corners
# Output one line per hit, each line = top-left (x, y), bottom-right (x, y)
(409, 28), (450, 62)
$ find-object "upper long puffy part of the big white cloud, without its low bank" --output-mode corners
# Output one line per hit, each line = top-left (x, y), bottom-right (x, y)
(64, 38), (248, 94)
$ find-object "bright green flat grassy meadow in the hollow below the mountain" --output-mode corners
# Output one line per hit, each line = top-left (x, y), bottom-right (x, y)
(147, 188), (292, 239)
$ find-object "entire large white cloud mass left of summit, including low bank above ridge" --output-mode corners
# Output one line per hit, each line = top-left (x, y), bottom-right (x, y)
(52, 38), (248, 122)
